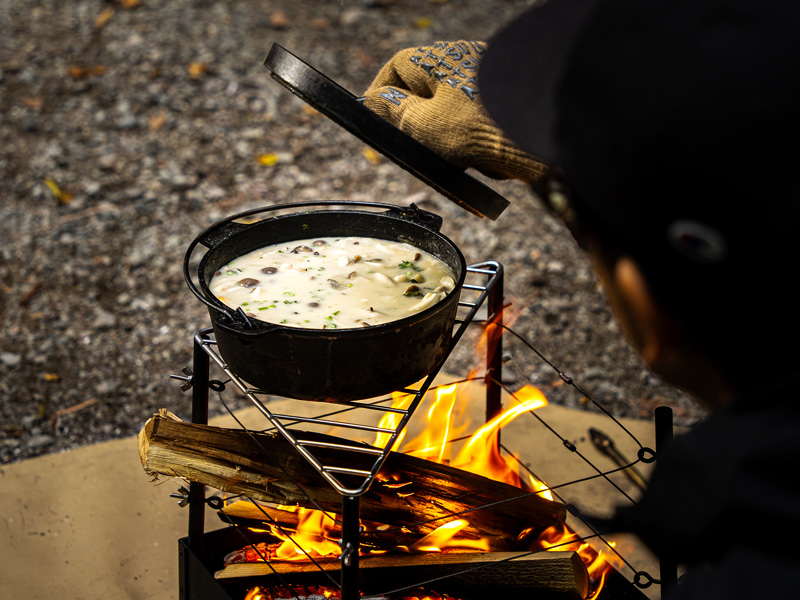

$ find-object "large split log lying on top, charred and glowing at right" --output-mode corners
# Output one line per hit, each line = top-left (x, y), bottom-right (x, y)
(139, 411), (566, 538)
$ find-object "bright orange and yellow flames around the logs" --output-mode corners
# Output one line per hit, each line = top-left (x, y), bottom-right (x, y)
(218, 384), (612, 598)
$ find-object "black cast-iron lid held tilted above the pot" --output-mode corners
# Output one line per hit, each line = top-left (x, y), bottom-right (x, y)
(264, 44), (509, 220)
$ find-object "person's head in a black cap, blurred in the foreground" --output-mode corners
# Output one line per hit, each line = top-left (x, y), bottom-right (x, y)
(479, 0), (800, 401)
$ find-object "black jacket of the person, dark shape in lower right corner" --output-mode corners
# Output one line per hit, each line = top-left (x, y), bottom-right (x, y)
(617, 381), (800, 600)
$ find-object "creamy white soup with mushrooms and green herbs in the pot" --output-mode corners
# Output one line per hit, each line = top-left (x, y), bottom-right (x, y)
(209, 237), (455, 329)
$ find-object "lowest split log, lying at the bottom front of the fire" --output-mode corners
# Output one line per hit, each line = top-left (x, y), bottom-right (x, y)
(214, 552), (589, 600)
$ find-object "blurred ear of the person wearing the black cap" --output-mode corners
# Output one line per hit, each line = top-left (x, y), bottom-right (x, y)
(612, 256), (673, 366)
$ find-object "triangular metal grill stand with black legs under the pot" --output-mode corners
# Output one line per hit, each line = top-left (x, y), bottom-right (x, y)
(180, 261), (503, 600)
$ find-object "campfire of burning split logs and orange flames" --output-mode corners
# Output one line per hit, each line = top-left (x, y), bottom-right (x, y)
(141, 384), (612, 599)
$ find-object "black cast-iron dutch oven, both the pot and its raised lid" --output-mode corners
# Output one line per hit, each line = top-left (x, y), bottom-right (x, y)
(184, 44), (508, 402)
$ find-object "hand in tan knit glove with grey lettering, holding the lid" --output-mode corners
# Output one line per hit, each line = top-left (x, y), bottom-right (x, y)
(364, 41), (547, 183)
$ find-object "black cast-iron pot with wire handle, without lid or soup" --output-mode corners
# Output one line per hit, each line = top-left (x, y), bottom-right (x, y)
(184, 202), (466, 402)
